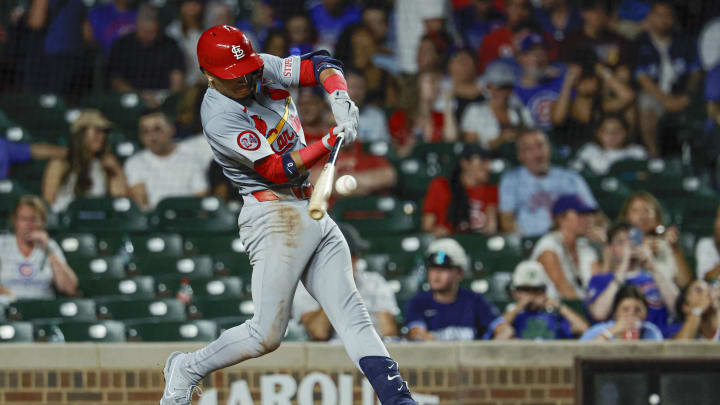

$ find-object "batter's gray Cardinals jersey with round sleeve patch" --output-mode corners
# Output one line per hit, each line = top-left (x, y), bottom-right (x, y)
(200, 54), (308, 194)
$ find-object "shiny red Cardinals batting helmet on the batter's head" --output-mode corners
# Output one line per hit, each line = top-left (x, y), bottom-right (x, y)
(197, 25), (263, 79)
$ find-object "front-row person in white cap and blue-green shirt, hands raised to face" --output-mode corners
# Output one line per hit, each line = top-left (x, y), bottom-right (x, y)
(497, 260), (589, 340)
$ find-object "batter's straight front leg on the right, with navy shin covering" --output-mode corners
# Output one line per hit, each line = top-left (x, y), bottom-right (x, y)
(302, 216), (416, 405)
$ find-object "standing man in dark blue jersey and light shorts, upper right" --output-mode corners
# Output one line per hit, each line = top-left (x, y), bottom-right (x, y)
(633, 0), (700, 156)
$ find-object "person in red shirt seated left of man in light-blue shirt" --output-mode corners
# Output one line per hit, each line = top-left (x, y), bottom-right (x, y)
(422, 145), (498, 237)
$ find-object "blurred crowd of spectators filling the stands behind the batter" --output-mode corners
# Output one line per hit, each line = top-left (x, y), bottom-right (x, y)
(0, 0), (720, 340)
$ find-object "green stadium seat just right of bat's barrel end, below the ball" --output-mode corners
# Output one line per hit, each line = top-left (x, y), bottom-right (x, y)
(331, 196), (420, 235)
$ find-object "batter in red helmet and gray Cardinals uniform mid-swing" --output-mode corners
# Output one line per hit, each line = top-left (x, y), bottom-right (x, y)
(160, 26), (416, 405)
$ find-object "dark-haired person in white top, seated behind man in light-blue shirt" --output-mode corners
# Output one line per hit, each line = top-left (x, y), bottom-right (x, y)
(572, 114), (647, 175)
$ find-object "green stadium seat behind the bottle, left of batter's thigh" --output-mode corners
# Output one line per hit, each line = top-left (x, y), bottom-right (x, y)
(157, 275), (245, 299)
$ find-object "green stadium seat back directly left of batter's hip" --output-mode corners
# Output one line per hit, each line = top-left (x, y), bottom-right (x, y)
(150, 197), (237, 234)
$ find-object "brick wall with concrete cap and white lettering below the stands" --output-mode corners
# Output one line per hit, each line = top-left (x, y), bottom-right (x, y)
(0, 341), (720, 405)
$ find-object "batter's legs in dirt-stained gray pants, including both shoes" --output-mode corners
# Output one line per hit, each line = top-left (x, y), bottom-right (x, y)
(161, 196), (415, 405)
